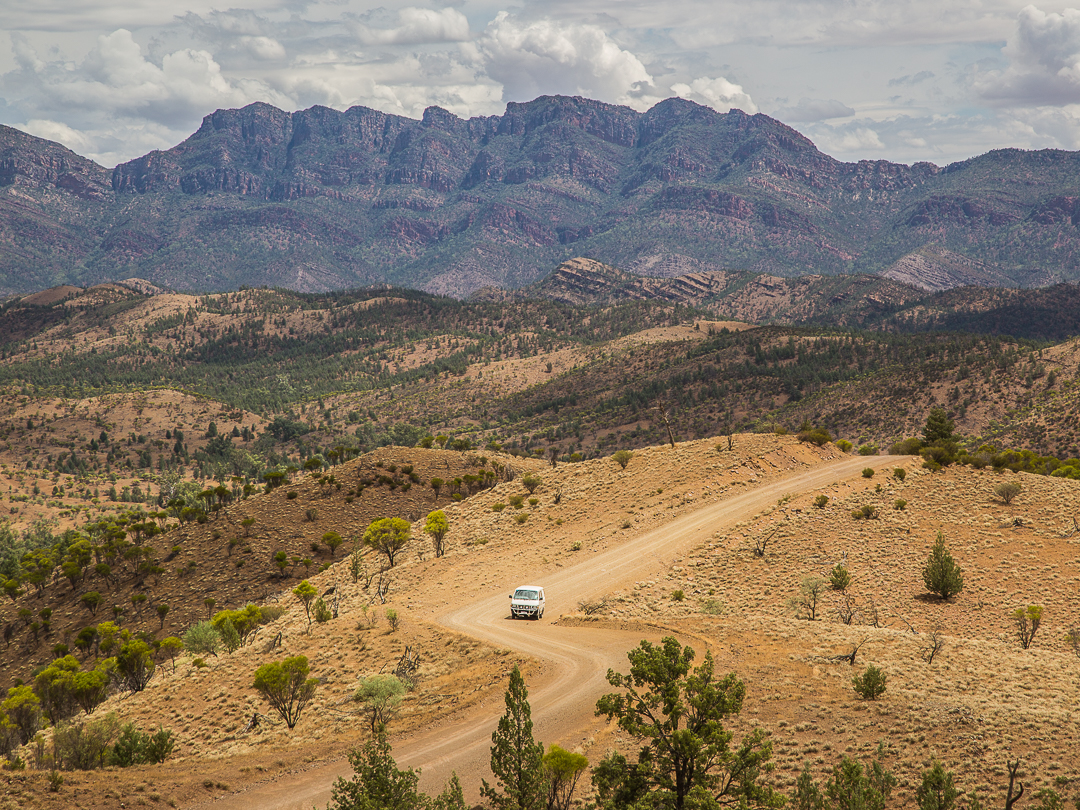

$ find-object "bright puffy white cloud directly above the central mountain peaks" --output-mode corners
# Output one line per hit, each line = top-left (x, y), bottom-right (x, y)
(475, 11), (652, 104)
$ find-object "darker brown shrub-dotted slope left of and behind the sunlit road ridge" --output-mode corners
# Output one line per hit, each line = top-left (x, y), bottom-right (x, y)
(0, 447), (540, 689)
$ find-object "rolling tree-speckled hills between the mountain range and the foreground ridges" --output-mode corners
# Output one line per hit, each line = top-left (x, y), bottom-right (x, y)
(6, 282), (1080, 473)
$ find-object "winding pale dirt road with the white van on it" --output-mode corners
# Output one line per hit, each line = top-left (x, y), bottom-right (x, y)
(205, 456), (903, 810)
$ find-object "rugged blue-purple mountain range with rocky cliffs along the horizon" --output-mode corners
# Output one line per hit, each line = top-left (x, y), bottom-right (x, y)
(0, 96), (1080, 297)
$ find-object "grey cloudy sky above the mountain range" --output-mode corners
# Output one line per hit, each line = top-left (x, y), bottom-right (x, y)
(0, 0), (1080, 166)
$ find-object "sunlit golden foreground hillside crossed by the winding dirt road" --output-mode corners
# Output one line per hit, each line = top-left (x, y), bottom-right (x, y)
(2, 434), (1080, 810)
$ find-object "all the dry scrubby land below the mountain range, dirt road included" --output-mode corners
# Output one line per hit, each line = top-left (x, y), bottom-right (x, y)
(0, 274), (1080, 810)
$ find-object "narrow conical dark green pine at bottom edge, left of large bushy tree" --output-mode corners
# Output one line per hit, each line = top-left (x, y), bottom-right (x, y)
(480, 665), (548, 810)
